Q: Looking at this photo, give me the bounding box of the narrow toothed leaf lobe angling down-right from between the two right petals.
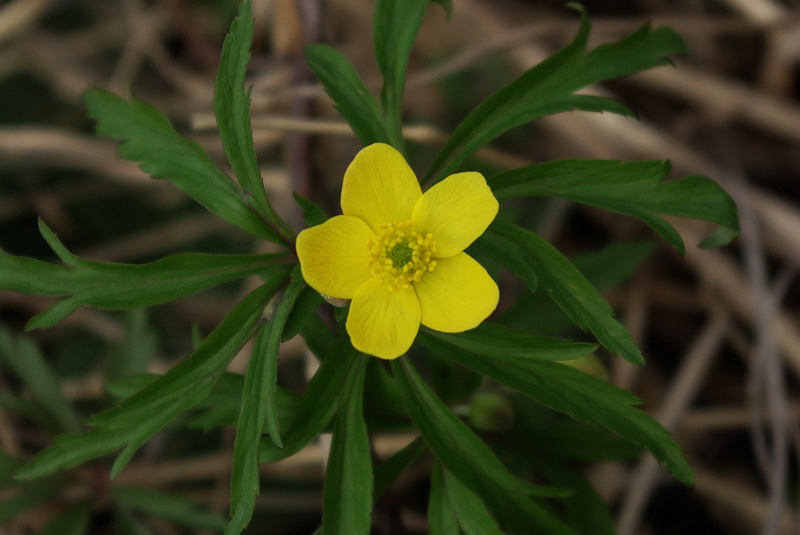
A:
[489,221,644,364]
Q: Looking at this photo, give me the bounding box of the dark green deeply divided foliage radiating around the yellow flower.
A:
[0,0,738,535]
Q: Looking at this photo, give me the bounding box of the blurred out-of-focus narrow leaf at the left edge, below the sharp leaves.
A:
[0,328,80,432]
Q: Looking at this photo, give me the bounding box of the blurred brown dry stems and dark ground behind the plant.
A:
[0,0,800,535]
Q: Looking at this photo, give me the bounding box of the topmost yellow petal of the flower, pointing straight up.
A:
[342,143,422,232]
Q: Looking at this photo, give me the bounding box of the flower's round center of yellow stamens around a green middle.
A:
[367,221,436,292]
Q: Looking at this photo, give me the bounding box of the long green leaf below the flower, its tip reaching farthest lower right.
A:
[443,342,694,486]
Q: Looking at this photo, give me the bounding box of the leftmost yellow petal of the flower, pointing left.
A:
[297,215,376,299]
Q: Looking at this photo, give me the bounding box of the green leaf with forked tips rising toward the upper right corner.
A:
[426,4,686,181]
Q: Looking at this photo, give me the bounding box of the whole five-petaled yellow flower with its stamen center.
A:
[297,143,499,359]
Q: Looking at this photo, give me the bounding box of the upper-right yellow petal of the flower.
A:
[411,172,499,257]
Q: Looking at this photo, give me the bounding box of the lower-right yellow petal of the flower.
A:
[414,253,500,333]
